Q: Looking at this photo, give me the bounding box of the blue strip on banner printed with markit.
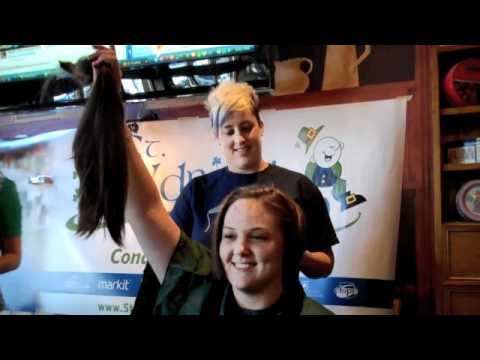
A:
[39,272,143,297]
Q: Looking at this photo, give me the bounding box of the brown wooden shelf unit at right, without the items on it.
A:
[429,45,480,315]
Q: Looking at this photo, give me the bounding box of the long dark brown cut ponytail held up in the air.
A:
[72,64,128,245]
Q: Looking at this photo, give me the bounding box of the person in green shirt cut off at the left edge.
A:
[0,172,22,311]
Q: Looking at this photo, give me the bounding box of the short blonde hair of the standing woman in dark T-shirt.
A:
[205,80,261,134]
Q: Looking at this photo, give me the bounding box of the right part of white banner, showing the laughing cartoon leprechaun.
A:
[263,98,407,314]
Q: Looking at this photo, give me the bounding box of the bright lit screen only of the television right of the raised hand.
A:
[114,45,256,68]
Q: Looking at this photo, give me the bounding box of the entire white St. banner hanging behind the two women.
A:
[0,98,406,314]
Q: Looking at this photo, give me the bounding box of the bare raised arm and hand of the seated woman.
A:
[83,46,180,282]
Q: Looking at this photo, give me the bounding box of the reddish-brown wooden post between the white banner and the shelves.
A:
[404,45,435,314]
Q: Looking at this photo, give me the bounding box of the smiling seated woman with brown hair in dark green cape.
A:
[154,185,333,316]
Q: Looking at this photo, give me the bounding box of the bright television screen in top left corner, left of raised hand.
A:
[0,45,100,83]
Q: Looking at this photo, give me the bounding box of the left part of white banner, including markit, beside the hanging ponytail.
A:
[0,129,146,314]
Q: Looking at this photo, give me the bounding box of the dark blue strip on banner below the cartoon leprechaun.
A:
[300,276,394,309]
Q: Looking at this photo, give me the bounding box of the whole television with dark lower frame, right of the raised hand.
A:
[114,45,271,100]
